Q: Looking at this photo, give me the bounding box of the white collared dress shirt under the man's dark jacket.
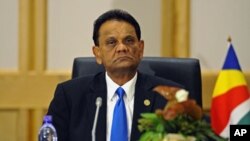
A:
[106,72,137,141]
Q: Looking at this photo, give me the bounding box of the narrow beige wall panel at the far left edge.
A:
[0,0,18,69]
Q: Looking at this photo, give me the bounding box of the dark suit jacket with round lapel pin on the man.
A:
[48,72,183,141]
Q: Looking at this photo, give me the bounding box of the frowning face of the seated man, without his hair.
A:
[93,20,144,73]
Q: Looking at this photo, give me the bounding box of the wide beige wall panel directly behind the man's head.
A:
[48,0,161,70]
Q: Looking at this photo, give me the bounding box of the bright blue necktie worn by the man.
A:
[110,87,128,141]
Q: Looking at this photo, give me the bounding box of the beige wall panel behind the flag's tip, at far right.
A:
[190,0,250,71]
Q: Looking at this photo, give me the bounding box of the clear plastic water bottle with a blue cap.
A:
[38,115,57,141]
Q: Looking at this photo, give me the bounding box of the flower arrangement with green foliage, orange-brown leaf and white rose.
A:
[138,86,226,141]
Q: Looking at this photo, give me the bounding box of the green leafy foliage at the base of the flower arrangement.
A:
[138,113,226,141]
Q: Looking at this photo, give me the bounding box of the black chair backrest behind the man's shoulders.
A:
[72,57,202,106]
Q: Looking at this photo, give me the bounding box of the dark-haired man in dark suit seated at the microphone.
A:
[48,10,180,141]
